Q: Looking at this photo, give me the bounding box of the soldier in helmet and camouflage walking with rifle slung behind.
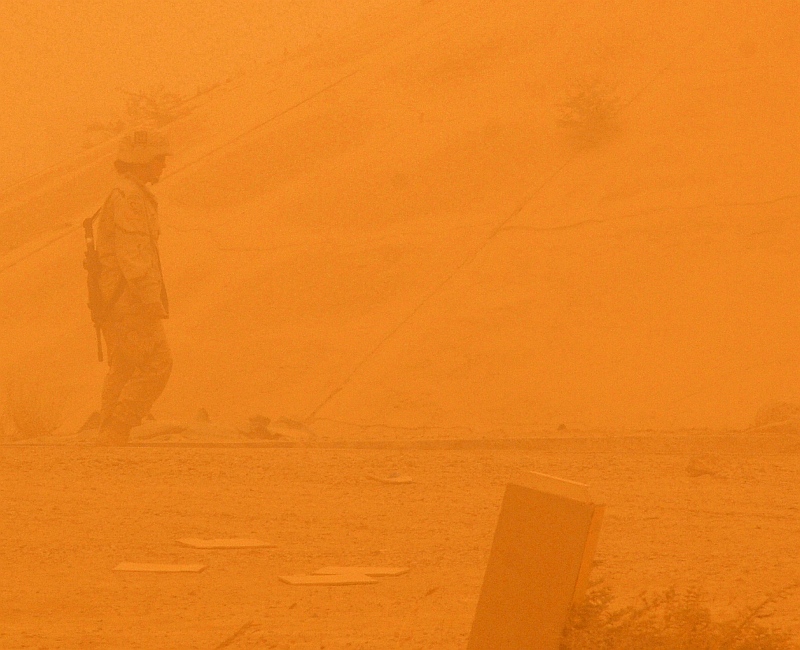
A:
[96,131,172,445]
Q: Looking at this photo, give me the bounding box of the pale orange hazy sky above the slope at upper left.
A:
[0,0,388,187]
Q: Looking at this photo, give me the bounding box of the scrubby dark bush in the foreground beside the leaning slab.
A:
[561,587,797,650]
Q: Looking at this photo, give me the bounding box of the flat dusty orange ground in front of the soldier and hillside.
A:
[0,433,800,650]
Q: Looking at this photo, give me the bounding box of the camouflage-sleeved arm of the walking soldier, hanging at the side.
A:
[113,192,161,305]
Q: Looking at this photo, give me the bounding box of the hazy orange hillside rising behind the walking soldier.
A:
[0,0,800,437]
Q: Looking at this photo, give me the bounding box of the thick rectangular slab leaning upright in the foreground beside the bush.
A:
[468,473,603,650]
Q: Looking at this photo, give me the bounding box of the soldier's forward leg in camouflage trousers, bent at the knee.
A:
[112,318,172,427]
